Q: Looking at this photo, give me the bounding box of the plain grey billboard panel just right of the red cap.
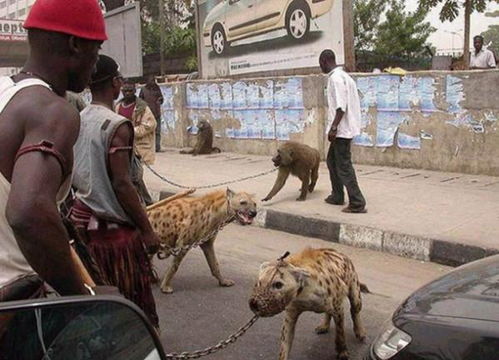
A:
[100,2,142,77]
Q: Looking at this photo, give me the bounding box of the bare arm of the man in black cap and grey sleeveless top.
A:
[109,123,159,252]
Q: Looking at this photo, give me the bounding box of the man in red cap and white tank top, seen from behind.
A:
[0,0,106,301]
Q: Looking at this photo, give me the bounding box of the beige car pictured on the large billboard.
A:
[203,0,333,55]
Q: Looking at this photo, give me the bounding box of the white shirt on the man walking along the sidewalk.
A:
[327,67,361,139]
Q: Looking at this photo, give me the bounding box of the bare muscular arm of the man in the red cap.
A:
[6,99,88,295]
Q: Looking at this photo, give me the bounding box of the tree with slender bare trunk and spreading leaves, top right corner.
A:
[419,0,499,68]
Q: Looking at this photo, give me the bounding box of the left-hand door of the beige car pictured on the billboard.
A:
[226,0,259,39]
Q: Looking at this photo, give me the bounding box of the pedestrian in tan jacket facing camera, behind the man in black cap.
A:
[116,80,157,165]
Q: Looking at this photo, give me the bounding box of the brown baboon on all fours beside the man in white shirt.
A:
[262,141,321,201]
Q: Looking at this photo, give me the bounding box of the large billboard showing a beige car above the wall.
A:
[197,0,344,78]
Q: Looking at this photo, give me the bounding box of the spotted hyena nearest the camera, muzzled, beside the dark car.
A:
[249,248,369,360]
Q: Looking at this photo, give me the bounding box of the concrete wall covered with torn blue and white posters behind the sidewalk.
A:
[162,70,499,176]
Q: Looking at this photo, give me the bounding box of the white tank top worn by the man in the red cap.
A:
[0,77,50,288]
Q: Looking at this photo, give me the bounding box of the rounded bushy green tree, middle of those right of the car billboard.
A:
[374,0,435,58]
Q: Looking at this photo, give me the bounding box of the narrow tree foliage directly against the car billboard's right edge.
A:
[353,0,386,52]
